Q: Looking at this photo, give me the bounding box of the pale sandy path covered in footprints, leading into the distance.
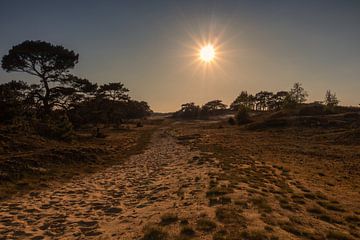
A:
[0,129,215,239]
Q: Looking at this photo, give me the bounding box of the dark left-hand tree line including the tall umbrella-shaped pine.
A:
[0,41,152,138]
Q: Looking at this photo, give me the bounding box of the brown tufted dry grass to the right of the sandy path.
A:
[171,114,360,240]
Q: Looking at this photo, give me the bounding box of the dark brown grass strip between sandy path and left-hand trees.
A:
[0,126,157,200]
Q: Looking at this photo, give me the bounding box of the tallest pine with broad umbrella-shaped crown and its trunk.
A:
[1,41,79,114]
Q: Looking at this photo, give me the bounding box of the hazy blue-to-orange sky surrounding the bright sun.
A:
[0,0,360,111]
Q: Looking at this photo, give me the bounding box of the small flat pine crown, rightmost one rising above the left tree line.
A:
[97,82,130,101]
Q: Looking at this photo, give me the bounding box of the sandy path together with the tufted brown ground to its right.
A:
[0,122,360,240]
